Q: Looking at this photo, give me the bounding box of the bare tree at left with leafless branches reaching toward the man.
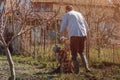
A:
[0,0,61,80]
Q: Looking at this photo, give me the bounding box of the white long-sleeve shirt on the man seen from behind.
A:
[60,10,88,37]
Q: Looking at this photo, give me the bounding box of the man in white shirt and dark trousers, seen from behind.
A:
[60,6,90,74]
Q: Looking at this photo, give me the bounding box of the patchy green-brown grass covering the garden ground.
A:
[0,49,120,80]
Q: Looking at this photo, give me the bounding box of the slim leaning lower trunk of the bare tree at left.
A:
[0,34,16,80]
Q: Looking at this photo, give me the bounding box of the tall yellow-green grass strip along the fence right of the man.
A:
[90,48,120,63]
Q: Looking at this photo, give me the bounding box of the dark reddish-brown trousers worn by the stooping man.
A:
[70,36,88,70]
